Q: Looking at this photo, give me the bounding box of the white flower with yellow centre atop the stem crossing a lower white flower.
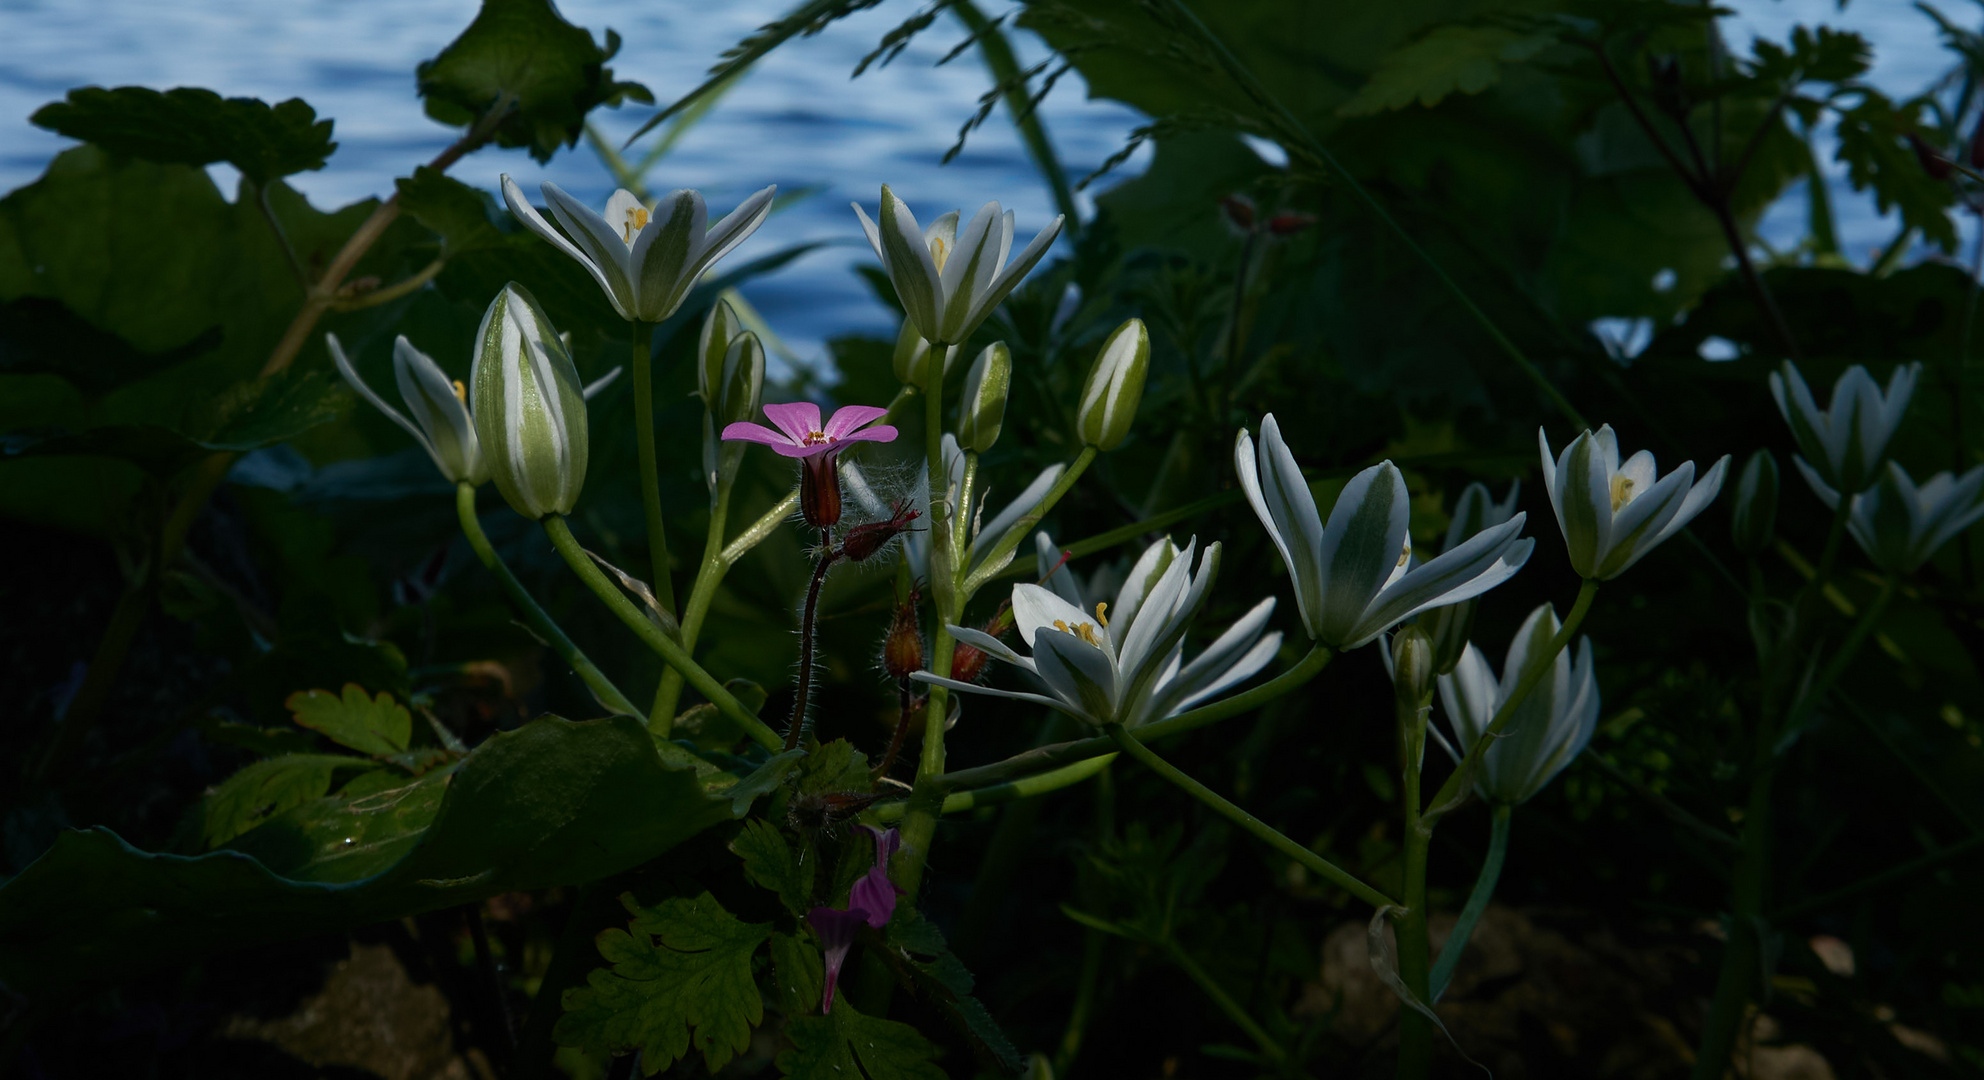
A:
[1536,425,1730,582]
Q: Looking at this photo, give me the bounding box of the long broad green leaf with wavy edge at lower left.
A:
[0,717,732,1001]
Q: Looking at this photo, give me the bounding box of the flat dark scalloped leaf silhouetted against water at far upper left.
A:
[28,85,337,187]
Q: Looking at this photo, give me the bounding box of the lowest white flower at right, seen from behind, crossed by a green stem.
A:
[1434,604,1599,806]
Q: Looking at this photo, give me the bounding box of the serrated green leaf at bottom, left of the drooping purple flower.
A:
[554,893,772,1076]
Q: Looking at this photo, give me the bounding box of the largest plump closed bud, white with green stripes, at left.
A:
[468,282,587,518]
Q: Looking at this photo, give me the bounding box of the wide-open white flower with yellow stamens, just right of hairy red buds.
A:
[913,538,1282,727]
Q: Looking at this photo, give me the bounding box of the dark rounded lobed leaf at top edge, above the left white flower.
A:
[419,0,655,161]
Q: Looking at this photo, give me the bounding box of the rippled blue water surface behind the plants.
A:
[0,0,1976,357]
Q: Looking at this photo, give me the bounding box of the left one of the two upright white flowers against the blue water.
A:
[502,173,778,322]
